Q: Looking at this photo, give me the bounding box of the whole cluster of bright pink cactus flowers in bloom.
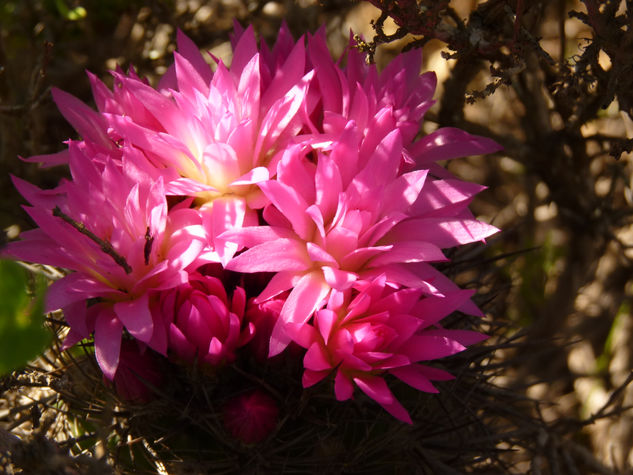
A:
[7,26,499,426]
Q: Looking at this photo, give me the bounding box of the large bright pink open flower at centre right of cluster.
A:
[222,119,497,356]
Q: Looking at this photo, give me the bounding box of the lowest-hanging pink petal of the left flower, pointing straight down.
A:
[95,308,123,381]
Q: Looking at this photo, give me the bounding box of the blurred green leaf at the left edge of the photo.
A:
[0,260,51,374]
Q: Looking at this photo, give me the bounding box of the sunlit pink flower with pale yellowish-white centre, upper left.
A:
[40,28,311,263]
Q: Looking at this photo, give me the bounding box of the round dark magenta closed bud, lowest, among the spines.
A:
[224,389,279,444]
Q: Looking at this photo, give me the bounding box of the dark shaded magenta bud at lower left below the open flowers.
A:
[113,340,163,403]
